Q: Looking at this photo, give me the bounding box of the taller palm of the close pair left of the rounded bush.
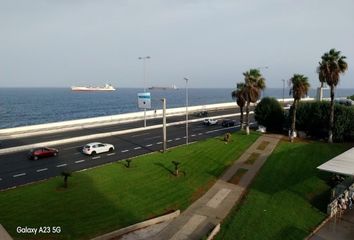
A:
[243,69,265,135]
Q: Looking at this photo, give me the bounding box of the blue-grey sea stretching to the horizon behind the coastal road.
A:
[0,88,354,129]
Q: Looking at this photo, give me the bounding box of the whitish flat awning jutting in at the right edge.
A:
[317,147,354,176]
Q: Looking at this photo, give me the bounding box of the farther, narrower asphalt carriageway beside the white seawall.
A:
[0,107,243,148]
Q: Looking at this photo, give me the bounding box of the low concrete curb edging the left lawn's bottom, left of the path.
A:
[91,210,181,240]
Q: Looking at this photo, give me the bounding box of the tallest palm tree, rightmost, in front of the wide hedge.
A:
[317,48,348,143]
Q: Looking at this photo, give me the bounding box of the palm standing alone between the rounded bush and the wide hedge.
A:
[289,74,310,142]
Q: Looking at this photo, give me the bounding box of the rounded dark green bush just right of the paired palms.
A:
[254,97,284,131]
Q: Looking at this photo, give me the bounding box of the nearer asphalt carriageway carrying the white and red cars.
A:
[0,113,254,190]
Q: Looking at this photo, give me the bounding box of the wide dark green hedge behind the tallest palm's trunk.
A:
[290,102,354,142]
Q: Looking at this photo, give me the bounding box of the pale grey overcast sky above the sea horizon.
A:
[0,0,354,88]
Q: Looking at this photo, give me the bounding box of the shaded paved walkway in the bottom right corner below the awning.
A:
[310,209,354,240]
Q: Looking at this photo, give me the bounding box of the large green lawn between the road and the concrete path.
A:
[0,133,259,240]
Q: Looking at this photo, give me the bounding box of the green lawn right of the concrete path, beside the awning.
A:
[216,141,350,240]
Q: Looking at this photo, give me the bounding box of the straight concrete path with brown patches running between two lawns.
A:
[148,135,281,240]
